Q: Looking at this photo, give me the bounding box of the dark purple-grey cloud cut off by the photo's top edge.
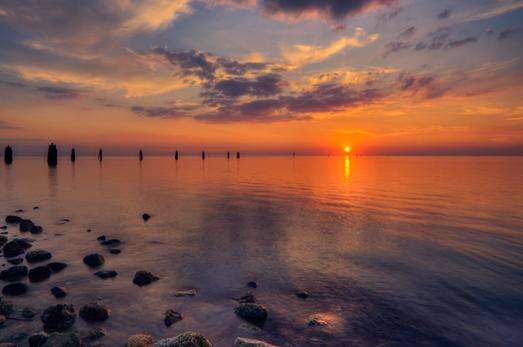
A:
[261,0,395,19]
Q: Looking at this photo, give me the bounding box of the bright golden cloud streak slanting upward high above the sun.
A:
[282,28,379,68]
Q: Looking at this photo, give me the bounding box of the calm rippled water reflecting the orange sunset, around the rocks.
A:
[0,157,523,346]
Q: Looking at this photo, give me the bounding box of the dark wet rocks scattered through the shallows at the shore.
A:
[0,212,308,347]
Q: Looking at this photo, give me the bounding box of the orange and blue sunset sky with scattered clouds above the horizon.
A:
[0,0,523,155]
